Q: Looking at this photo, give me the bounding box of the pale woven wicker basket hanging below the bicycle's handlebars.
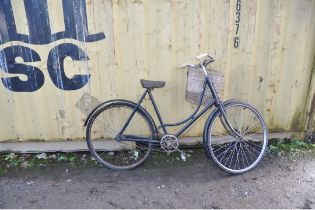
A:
[185,68,224,104]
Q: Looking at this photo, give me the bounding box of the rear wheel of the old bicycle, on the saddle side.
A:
[86,102,154,170]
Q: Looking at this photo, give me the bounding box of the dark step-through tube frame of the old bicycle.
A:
[115,76,223,143]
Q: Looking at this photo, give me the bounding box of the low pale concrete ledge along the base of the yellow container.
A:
[0,132,294,153]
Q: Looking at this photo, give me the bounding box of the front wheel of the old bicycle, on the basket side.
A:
[205,102,268,174]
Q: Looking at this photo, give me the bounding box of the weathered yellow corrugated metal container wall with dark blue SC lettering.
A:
[0,0,315,141]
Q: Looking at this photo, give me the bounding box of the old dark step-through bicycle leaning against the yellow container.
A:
[84,54,268,174]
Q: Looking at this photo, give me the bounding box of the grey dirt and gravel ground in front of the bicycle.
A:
[0,150,315,208]
